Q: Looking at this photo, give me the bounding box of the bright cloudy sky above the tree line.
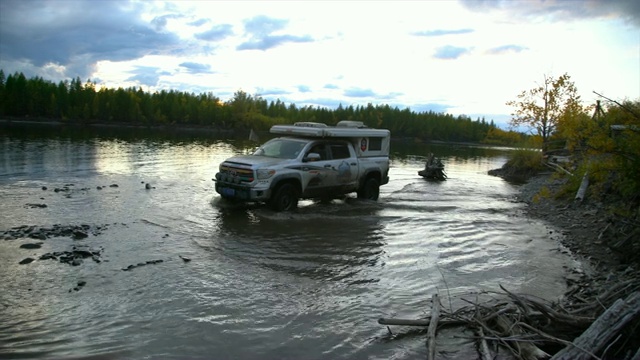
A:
[0,0,640,126]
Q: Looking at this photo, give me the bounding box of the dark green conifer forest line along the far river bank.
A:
[0,70,526,145]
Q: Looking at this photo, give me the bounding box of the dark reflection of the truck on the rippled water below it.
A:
[212,201,384,282]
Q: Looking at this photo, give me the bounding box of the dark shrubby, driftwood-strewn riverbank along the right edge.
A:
[490,169,640,359]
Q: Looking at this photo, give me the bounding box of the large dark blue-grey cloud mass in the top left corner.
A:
[0,0,182,78]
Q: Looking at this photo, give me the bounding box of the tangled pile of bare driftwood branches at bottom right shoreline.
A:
[378,274,640,360]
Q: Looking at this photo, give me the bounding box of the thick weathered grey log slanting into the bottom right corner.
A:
[551,291,640,360]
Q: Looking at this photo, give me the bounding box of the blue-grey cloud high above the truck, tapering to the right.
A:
[236,16,313,51]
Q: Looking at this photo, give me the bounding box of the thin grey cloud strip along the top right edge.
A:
[459,0,640,26]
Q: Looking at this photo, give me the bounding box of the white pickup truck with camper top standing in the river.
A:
[214,120,390,211]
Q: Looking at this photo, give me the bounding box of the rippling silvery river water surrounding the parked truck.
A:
[0,124,571,359]
